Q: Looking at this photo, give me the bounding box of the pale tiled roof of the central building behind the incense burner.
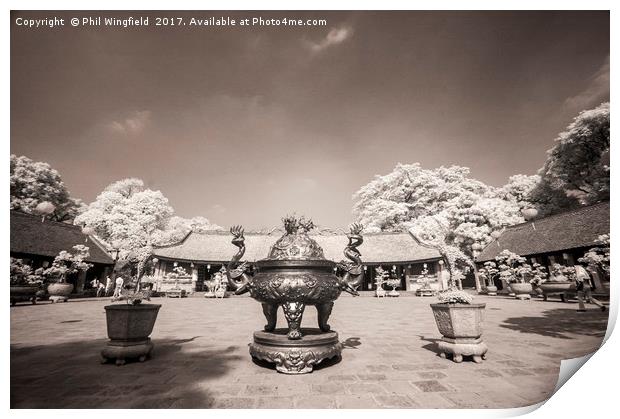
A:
[154,232,440,263]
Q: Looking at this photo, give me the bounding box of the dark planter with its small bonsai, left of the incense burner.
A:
[101,260,161,365]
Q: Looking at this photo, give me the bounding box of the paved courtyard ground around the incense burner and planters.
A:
[11,296,607,408]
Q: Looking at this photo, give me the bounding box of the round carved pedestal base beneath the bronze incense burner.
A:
[250,329,342,374]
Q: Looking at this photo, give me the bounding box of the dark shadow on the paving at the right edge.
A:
[500,308,608,339]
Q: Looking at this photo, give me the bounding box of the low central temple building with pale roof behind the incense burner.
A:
[153,230,442,292]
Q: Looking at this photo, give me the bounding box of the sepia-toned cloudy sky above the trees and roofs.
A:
[10,11,609,228]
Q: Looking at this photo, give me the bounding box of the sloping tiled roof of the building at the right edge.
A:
[476,202,609,262]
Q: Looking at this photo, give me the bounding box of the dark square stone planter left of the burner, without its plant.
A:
[101,304,161,365]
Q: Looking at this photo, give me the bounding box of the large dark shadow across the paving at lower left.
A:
[11,336,241,409]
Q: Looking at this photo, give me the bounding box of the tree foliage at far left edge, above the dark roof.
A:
[10,154,83,221]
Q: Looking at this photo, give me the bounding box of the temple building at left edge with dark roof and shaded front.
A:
[10,211,114,294]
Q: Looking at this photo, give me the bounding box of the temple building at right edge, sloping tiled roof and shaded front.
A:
[476,202,610,291]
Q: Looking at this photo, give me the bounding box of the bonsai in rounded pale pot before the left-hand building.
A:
[36,244,93,303]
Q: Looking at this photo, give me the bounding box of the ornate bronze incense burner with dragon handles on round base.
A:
[227,217,364,374]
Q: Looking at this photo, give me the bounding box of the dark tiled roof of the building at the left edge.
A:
[10,211,114,264]
